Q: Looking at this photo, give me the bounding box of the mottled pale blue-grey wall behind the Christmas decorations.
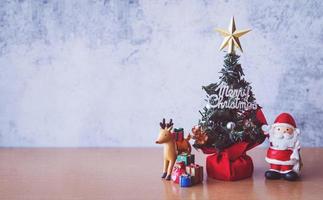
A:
[0,0,323,146]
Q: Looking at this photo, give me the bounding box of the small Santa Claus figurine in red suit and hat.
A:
[263,113,301,181]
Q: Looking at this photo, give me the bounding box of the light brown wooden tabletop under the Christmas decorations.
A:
[0,148,323,200]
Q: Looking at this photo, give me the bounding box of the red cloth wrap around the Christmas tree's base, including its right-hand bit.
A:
[202,109,267,181]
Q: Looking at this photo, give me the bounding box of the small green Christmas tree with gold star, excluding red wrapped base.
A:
[193,18,265,151]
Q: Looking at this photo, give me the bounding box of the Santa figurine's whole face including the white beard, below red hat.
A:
[269,124,297,150]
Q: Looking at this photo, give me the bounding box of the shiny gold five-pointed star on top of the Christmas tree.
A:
[215,17,251,54]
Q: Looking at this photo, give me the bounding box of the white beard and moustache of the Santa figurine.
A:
[269,130,297,150]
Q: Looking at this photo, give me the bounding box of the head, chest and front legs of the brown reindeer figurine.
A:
[156,119,177,181]
